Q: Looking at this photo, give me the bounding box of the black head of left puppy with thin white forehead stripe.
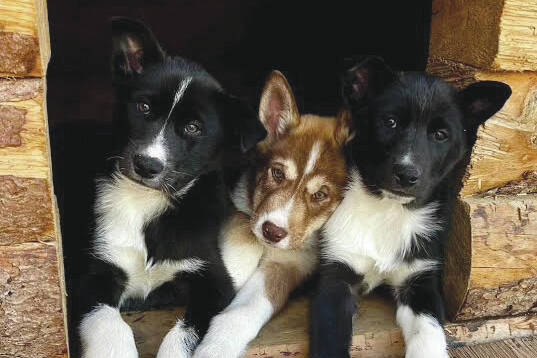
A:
[111,18,265,192]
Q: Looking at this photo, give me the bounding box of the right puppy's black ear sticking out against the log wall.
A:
[458,81,511,128]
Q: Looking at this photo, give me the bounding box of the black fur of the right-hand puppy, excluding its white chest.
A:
[310,57,511,357]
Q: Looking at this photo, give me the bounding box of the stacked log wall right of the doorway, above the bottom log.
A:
[427,0,537,321]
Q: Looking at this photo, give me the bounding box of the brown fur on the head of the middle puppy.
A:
[251,73,350,248]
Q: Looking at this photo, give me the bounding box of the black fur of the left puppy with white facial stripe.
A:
[71,18,265,357]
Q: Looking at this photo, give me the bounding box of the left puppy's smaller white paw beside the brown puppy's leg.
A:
[157,320,198,358]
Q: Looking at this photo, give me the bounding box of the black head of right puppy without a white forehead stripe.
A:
[343,57,511,205]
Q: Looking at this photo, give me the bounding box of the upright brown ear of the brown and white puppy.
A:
[259,71,300,138]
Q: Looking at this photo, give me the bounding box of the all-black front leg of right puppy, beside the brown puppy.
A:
[310,262,363,358]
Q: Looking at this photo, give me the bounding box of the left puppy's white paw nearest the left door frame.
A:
[80,305,138,358]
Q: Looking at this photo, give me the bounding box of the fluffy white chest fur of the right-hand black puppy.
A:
[323,173,440,288]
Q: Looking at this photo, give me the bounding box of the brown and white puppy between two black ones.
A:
[194,71,349,358]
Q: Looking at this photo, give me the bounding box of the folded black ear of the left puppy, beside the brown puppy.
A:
[220,93,267,153]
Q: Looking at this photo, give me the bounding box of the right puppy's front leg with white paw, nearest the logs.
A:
[397,272,448,358]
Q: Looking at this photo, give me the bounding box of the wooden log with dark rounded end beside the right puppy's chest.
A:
[444,172,537,321]
